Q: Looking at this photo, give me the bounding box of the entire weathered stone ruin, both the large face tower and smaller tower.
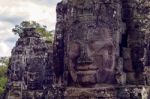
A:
[6,0,150,99]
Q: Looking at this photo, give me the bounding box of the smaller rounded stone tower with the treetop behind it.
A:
[5,28,53,99]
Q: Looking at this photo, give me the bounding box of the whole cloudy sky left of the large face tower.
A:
[0,0,61,57]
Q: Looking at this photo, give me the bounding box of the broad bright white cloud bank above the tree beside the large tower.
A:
[0,0,56,29]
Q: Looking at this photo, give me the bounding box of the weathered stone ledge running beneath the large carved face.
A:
[64,85,150,99]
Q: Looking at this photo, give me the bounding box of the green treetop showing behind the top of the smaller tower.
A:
[12,21,54,43]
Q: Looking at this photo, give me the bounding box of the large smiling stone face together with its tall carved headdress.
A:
[56,0,125,84]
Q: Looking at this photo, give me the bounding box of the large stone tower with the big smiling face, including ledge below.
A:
[54,0,150,99]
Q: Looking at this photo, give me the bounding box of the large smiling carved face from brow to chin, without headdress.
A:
[67,24,115,84]
